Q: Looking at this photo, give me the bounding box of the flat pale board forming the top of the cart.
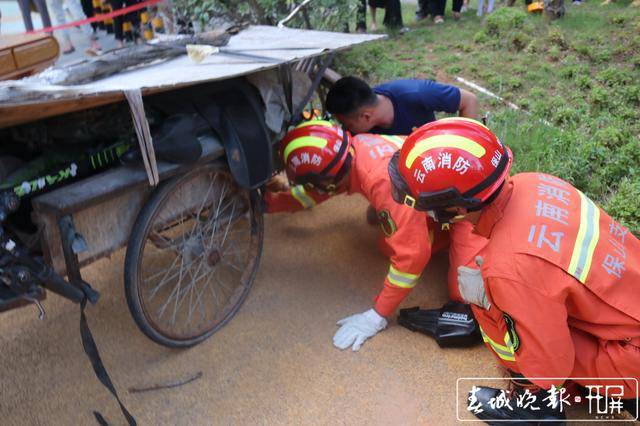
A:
[0,26,385,128]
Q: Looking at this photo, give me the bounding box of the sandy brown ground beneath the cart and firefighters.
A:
[0,196,502,425]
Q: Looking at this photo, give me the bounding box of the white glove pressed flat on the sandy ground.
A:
[333,309,387,352]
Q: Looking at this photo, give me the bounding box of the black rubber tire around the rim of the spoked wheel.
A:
[124,165,264,348]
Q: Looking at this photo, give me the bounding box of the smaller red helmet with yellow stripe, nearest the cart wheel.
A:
[280,120,351,191]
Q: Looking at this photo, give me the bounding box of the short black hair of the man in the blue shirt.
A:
[326,76,378,115]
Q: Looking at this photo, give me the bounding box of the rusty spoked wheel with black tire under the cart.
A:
[124,165,263,347]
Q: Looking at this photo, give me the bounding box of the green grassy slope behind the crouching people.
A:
[335,0,640,235]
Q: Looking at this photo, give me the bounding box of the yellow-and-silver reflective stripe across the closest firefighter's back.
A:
[568,191,600,284]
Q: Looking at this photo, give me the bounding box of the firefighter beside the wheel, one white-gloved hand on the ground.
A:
[264,120,486,351]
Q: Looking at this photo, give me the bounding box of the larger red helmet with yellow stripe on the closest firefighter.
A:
[389,117,512,222]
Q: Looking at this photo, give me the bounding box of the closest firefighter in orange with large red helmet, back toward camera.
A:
[389,120,640,424]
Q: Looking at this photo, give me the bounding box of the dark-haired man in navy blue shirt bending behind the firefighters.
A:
[326,76,478,135]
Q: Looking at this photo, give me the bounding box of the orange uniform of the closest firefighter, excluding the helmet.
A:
[474,173,640,398]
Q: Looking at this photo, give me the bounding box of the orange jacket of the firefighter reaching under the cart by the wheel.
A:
[265,134,446,316]
